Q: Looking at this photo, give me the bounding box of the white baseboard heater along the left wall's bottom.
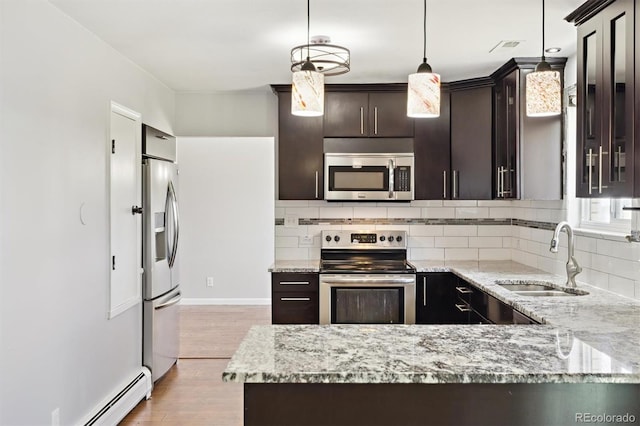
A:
[85,367,153,426]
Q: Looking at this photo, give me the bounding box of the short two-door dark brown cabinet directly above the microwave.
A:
[324,84,413,137]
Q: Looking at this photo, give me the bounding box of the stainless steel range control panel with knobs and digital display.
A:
[322,230,407,249]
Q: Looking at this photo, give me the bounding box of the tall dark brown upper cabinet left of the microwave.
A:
[272,85,324,200]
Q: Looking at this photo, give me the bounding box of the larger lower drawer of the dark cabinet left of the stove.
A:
[271,292,320,324]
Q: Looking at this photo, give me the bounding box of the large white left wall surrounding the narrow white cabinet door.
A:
[0,0,174,425]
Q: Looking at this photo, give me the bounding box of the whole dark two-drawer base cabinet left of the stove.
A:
[271,272,320,324]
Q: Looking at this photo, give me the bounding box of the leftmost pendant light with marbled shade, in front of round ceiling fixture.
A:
[291,0,324,117]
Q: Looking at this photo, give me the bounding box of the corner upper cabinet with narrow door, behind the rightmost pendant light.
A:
[491,58,567,200]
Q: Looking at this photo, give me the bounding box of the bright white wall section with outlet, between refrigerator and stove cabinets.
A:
[178,137,275,304]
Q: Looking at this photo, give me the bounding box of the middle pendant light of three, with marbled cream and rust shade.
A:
[407,0,440,118]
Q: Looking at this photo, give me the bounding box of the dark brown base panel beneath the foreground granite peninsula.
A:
[244,383,640,426]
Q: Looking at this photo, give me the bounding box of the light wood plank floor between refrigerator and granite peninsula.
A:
[120,306,271,426]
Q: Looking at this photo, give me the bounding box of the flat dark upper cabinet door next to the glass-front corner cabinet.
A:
[448,77,493,200]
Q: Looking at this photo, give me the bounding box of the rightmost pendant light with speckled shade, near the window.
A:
[525,0,562,117]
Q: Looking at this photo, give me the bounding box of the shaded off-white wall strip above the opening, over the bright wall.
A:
[175,87,278,136]
